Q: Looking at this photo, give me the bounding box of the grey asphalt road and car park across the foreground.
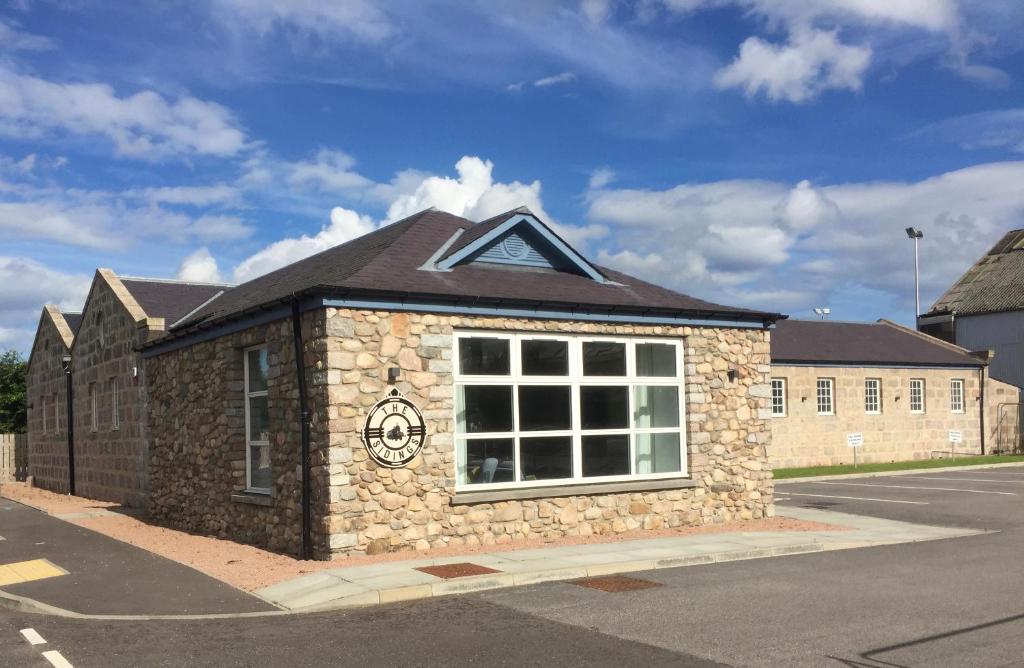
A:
[0,467,1024,667]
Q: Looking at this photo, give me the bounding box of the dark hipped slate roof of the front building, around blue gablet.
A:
[169,210,781,333]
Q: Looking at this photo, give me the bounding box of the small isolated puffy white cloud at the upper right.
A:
[715,30,871,102]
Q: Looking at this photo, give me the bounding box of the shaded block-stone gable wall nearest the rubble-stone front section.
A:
[72,269,151,507]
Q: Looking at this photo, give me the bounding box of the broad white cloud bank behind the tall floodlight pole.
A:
[589,162,1024,315]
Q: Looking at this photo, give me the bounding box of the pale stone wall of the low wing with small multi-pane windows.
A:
[768,365,1017,468]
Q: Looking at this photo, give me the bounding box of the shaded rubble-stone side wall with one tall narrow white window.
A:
[145,310,325,557]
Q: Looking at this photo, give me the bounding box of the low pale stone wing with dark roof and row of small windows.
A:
[768,320,1019,468]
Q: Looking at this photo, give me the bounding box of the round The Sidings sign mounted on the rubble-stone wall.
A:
[362,389,427,468]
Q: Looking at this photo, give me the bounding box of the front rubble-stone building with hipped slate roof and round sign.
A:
[141,209,779,558]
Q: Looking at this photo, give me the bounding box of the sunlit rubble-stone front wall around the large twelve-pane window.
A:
[316,308,774,555]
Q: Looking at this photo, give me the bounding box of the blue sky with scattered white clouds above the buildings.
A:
[0,0,1024,350]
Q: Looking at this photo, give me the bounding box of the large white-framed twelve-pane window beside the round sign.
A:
[455,332,686,489]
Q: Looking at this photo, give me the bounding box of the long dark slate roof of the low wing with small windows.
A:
[771,320,984,367]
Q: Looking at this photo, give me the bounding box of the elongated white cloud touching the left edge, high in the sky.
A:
[0,64,246,161]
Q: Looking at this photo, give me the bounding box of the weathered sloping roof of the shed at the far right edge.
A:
[926,229,1024,316]
